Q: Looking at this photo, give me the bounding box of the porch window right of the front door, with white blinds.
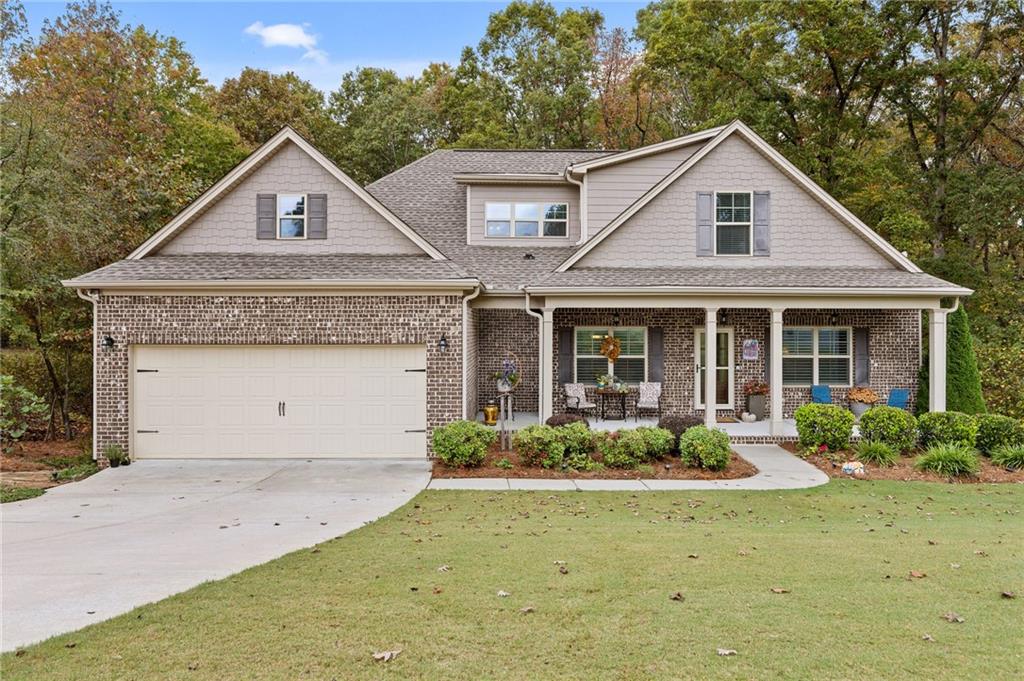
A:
[782,327,853,387]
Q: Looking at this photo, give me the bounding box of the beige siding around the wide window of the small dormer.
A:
[469,184,580,247]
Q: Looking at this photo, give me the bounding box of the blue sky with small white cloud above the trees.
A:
[26,0,646,90]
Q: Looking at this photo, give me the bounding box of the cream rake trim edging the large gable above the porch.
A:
[555,121,922,272]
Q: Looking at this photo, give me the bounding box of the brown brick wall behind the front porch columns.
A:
[554,308,921,418]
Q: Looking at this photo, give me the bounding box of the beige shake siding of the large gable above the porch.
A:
[575,136,894,269]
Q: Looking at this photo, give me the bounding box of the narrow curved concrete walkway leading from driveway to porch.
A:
[428,444,828,492]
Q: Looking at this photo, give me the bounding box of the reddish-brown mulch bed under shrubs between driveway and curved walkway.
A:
[433,445,758,480]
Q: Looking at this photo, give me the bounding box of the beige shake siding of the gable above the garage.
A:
[160,142,422,255]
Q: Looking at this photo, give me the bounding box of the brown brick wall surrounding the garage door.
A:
[94,296,462,454]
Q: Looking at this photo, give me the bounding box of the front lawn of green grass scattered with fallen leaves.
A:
[2,480,1024,681]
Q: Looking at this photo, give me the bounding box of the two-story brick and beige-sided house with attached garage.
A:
[66,122,971,458]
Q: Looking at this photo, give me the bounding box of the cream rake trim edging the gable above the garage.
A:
[127,126,447,260]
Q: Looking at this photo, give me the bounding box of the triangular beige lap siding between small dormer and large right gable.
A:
[587,144,701,237]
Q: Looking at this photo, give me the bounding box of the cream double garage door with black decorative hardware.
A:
[131,345,427,459]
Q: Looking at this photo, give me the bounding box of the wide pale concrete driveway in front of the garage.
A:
[0,460,430,651]
